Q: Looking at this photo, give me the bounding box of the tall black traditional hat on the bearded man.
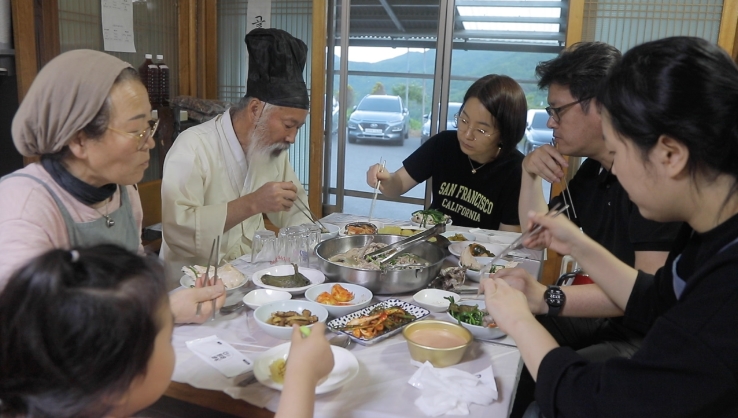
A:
[245,29,310,109]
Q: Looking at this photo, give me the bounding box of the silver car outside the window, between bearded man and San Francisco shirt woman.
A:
[348,94,410,145]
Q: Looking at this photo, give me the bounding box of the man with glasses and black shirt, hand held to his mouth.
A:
[507,42,680,417]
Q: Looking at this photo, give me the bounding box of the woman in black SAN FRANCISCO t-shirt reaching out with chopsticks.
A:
[367,74,527,232]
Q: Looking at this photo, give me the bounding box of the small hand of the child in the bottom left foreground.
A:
[285,322,334,387]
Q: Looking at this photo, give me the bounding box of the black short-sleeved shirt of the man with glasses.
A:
[551,158,682,266]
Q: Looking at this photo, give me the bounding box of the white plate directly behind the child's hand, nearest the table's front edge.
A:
[254,343,359,395]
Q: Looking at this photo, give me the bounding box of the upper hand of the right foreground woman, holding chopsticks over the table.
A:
[523,212,587,255]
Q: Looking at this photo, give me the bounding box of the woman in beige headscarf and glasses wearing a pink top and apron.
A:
[0,50,225,322]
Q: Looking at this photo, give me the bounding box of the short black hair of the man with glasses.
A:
[536,42,621,112]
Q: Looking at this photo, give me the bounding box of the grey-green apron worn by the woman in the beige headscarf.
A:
[0,174,140,253]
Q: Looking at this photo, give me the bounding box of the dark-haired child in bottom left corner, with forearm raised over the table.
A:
[0,244,334,418]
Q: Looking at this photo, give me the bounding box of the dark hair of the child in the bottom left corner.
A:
[0,244,167,418]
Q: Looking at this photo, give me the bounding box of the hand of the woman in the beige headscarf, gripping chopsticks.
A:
[169,274,226,324]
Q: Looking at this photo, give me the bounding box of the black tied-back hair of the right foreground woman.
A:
[597,36,738,198]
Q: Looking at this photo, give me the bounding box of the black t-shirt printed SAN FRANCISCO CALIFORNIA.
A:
[403,131,523,229]
